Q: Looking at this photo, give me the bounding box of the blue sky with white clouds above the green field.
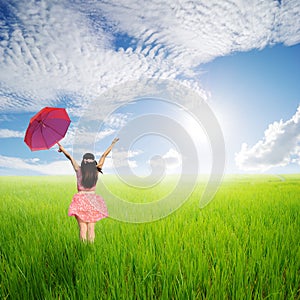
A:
[0,0,300,175]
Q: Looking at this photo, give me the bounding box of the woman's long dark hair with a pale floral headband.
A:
[81,153,98,189]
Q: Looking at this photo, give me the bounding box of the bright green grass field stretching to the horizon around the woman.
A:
[0,175,300,300]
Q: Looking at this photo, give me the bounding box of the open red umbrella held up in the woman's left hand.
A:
[24,107,71,151]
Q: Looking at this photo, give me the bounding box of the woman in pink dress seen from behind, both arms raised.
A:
[58,138,119,242]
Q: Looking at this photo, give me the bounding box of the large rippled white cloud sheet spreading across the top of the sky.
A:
[0,0,300,115]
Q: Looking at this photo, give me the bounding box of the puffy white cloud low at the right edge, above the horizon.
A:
[235,106,300,171]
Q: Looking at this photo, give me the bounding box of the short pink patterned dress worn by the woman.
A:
[68,167,108,223]
